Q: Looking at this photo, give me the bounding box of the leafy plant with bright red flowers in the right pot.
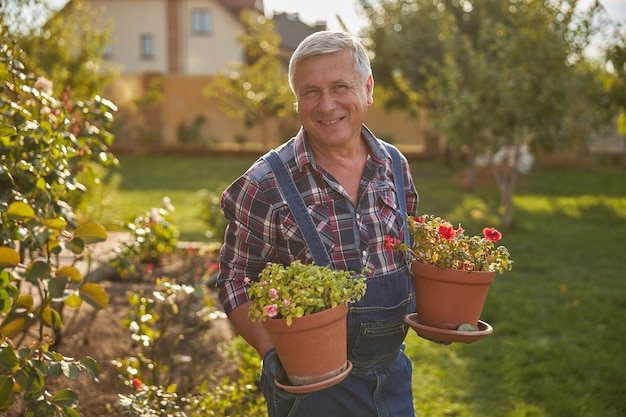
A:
[385,214,513,274]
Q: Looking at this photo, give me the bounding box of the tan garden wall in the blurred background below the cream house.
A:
[107,74,425,153]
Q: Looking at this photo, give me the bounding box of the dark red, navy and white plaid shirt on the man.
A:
[217,126,418,314]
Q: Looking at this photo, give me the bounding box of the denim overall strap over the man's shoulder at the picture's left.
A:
[263,150,330,266]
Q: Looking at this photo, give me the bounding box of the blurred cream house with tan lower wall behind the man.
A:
[84,0,419,153]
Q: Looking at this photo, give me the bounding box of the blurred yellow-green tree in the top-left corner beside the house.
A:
[0,0,120,99]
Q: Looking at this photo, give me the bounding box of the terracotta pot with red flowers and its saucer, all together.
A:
[386,214,513,343]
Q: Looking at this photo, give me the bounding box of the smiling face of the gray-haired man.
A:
[294,50,374,148]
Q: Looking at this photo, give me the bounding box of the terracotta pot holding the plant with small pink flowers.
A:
[263,303,348,385]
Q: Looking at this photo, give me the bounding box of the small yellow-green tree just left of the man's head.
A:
[204,10,294,147]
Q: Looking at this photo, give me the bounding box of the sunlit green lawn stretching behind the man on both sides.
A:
[103,156,626,417]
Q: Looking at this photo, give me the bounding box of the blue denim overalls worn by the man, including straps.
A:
[260,147,415,417]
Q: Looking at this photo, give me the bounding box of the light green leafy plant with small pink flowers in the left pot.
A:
[245,261,367,325]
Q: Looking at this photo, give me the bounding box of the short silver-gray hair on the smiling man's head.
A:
[289,30,372,93]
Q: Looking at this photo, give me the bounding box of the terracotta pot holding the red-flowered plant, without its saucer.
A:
[411,262,495,330]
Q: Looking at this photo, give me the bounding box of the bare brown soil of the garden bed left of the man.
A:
[0,237,236,417]
